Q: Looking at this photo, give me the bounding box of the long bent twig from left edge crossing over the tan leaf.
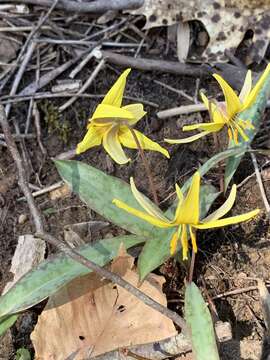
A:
[0,105,187,333]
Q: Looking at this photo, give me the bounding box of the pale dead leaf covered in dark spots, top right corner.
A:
[129,0,270,61]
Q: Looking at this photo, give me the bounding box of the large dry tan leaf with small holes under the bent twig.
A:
[31,246,176,360]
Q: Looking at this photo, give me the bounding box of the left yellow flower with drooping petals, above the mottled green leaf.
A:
[76,69,170,164]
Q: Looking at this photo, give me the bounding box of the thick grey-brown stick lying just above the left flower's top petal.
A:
[101,50,208,77]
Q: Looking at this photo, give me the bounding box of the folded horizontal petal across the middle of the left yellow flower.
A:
[91,104,134,125]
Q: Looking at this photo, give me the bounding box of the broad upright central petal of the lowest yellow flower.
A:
[177,171,200,224]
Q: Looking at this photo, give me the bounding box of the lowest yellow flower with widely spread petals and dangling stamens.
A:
[113,172,260,260]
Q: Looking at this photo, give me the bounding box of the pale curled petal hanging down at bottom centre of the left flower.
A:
[103,126,130,165]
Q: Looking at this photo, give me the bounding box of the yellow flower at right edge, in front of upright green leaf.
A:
[165,64,270,145]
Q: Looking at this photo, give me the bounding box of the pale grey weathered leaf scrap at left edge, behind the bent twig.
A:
[3,234,46,294]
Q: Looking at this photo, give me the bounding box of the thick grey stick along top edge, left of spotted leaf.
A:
[8,0,143,13]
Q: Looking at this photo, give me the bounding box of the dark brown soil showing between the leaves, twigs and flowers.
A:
[0,9,270,360]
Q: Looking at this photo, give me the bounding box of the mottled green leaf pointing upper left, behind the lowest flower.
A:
[55,160,155,237]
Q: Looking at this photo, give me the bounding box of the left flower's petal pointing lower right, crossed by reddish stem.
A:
[119,126,170,158]
